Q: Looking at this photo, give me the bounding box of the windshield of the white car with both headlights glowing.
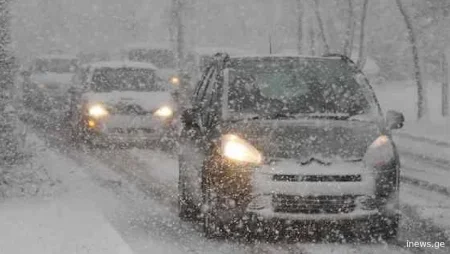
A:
[91,68,165,92]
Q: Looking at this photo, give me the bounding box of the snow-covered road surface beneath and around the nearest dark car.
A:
[8,111,450,253]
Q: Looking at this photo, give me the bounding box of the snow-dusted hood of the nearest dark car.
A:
[225,119,381,163]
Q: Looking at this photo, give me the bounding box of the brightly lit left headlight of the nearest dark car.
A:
[222,134,262,164]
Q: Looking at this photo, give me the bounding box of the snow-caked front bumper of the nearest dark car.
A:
[213,161,399,222]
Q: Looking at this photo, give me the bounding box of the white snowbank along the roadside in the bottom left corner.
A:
[0,134,132,254]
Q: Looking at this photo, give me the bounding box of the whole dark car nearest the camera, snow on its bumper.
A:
[178,54,404,239]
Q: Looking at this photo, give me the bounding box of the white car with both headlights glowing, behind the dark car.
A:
[69,61,176,146]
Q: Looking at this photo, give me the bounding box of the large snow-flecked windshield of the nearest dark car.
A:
[228,58,377,116]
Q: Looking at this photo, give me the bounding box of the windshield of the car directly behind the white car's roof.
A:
[128,49,176,69]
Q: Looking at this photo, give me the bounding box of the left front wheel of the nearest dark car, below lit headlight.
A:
[203,189,224,239]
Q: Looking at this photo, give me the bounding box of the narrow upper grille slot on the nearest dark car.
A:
[272,174,362,182]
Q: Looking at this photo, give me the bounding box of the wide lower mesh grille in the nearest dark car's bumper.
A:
[272,195,356,214]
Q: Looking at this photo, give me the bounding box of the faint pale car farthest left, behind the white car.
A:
[23,54,79,112]
